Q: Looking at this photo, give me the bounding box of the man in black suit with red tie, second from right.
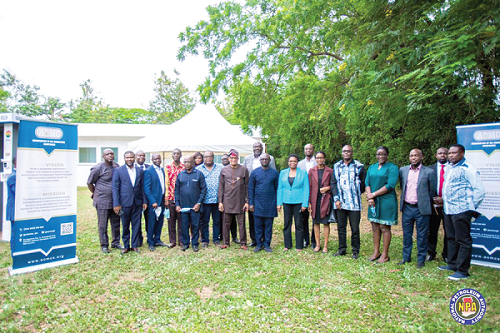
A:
[425,147,449,262]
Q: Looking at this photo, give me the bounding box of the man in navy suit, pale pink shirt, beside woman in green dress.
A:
[398,149,436,268]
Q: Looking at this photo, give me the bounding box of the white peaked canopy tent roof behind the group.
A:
[128,105,255,155]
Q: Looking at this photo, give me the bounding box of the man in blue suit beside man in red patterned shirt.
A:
[144,154,167,251]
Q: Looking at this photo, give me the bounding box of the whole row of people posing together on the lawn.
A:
[87,142,484,280]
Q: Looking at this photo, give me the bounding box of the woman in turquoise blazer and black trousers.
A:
[277,154,309,251]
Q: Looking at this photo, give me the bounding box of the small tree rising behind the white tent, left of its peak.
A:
[149,71,195,124]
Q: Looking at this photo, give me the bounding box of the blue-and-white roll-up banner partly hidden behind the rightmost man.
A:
[457,123,500,268]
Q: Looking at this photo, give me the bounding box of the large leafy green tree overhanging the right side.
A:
[178,0,500,166]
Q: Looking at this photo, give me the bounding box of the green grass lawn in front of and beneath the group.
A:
[0,188,500,332]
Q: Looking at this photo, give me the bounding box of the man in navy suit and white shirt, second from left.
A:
[112,151,147,254]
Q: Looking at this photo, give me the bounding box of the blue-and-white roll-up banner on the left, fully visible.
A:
[9,120,78,275]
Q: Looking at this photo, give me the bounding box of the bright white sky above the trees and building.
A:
[0,0,233,108]
